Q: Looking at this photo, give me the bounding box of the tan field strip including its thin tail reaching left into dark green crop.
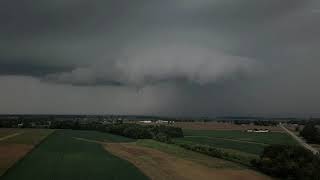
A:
[37,133,268,180]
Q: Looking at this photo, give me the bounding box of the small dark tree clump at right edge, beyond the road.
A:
[300,122,320,144]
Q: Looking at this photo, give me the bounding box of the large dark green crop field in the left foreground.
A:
[1,130,148,180]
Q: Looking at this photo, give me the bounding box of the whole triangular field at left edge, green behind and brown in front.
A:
[0,129,53,176]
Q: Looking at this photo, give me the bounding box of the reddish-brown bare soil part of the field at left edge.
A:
[0,144,33,176]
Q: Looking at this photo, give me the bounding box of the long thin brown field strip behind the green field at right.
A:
[174,122,284,132]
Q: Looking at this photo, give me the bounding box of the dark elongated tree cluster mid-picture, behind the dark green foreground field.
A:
[105,124,183,142]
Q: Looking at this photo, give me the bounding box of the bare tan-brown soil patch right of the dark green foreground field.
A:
[104,143,270,180]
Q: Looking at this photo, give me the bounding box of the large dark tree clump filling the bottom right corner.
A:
[252,145,320,180]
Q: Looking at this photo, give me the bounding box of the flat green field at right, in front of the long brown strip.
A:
[175,130,296,155]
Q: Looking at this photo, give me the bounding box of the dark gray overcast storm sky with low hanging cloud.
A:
[0,0,320,116]
